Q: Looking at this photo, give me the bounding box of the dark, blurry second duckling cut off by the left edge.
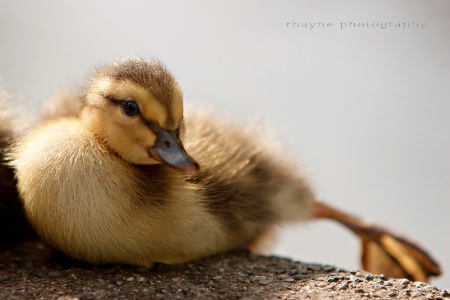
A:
[0,93,36,245]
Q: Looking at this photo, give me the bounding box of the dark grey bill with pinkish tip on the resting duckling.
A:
[149,128,200,174]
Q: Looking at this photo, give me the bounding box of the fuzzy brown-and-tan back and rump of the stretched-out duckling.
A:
[183,112,314,247]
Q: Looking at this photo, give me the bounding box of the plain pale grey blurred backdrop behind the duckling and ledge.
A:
[0,0,450,288]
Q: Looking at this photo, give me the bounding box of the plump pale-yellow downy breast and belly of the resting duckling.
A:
[12,119,235,265]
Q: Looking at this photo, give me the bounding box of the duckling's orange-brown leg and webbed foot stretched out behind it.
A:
[314,202,441,281]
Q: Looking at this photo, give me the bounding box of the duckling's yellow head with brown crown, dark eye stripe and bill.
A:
[80,59,199,174]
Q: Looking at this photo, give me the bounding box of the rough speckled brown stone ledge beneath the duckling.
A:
[0,241,450,299]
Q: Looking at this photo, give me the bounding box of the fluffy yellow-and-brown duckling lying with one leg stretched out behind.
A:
[9,59,440,282]
